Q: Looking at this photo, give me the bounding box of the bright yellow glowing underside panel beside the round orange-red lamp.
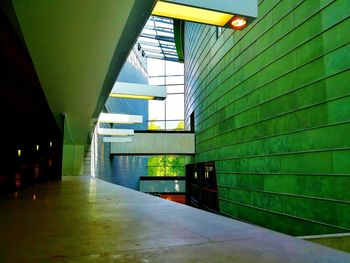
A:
[152,1,233,26]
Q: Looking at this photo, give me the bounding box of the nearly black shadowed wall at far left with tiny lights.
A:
[0,12,62,195]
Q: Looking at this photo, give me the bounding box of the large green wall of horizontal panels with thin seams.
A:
[184,0,350,235]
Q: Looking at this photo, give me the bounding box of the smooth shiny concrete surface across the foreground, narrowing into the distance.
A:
[0,177,350,263]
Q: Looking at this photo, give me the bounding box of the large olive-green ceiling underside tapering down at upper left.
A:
[12,0,155,144]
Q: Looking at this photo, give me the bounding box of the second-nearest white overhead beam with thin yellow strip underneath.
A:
[110,82,167,100]
